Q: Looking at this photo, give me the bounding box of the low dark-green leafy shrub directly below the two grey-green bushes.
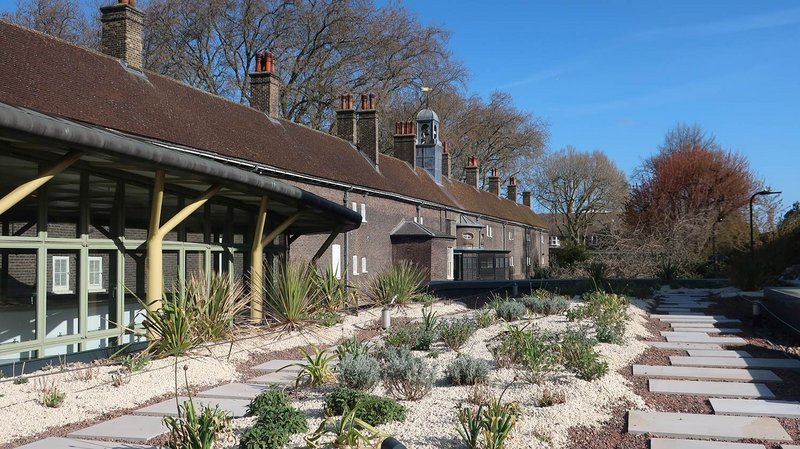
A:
[325,387,406,426]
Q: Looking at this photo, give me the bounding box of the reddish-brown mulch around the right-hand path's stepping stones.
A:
[568,290,800,449]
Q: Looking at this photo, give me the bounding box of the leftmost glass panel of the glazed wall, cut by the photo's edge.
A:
[0,249,37,344]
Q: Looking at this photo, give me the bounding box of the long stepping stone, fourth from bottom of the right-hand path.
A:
[648,379,775,398]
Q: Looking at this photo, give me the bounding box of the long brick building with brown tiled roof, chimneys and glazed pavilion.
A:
[0,2,548,364]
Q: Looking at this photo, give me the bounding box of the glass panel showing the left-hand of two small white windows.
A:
[45,249,81,338]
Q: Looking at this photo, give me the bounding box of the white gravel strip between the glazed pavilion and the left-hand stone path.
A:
[0,303,466,443]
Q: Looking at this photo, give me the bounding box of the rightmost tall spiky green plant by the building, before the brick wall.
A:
[367,261,425,306]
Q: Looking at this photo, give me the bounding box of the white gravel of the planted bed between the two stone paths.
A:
[224,300,650,449]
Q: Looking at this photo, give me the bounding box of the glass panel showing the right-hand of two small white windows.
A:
[86,251,118,331]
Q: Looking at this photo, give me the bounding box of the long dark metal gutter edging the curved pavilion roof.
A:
[0,102,361,230]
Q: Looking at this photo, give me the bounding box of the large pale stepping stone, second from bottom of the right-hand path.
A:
[628,410,792,441]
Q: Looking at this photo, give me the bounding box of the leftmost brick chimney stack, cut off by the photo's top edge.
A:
[100,0,144,71]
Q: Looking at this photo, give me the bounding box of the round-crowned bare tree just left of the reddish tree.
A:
[531,146,628,244]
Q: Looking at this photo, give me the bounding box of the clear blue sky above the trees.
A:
[404,0,800,208]
